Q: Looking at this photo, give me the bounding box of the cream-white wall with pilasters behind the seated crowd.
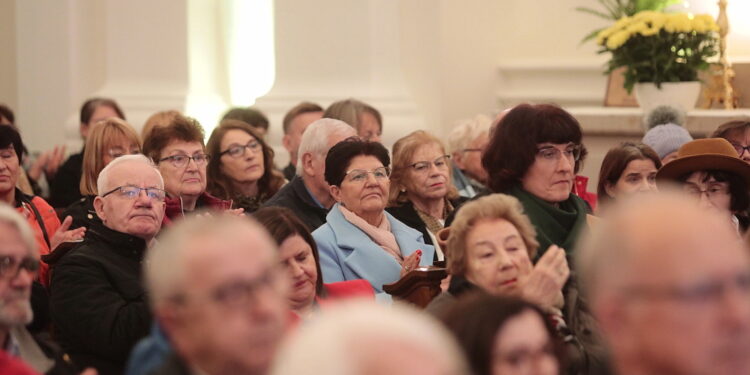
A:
[5,0,750,164]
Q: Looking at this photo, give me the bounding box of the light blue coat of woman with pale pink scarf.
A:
[313,204,435,300]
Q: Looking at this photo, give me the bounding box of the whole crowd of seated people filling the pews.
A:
[0,98,750,375]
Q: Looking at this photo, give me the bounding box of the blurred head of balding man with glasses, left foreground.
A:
[145,215,289,375]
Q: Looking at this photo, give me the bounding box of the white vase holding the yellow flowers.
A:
[635,81,701,113]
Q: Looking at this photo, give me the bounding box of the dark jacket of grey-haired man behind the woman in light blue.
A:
[263,176,328,232]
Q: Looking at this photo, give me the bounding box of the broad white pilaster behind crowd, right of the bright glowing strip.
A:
[256,0,423,165]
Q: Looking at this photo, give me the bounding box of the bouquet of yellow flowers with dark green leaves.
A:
[596,11,719,93]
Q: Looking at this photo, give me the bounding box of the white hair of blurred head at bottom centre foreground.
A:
[271,300,468,375]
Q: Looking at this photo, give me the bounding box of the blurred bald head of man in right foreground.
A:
[577,192,750,375]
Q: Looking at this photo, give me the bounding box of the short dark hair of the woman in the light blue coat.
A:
[325,138,391,186]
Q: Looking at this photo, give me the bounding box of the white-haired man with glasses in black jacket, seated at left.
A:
[50,155,166,375]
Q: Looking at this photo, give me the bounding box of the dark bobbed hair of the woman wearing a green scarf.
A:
[482,104,588,193]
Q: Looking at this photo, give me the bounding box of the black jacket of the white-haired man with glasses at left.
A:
[50,224,151,375]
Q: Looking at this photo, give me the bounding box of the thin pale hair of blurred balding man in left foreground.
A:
[143,214,274,308]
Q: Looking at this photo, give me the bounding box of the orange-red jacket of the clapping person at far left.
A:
[16,192,60,287]
